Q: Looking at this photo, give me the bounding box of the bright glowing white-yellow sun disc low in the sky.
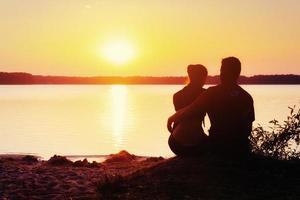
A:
[101,39,136,66]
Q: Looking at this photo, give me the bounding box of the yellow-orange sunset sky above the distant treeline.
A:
[0,0,300,76]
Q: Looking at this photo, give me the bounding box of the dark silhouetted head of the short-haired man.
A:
[220,57,241,84]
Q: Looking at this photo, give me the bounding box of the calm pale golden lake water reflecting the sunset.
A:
[0,85,300,158]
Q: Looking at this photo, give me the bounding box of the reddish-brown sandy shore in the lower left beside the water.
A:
[0,151,164,200]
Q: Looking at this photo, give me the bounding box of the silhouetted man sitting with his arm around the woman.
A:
[168,57,254,154]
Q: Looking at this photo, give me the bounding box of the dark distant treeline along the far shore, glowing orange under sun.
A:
[0,72,300,84]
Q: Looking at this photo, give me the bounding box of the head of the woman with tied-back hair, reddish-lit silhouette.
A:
[187,64,207,86]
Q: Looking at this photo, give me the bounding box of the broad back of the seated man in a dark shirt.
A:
[206,84,254,152]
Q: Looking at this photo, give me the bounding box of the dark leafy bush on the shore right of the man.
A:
[250,106,300,160]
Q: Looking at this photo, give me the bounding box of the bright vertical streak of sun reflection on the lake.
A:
[110,85,127,151]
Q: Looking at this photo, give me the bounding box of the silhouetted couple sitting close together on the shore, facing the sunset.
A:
[167,57,254,156]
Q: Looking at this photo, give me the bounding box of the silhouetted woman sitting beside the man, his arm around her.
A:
[168,64,207,155]
